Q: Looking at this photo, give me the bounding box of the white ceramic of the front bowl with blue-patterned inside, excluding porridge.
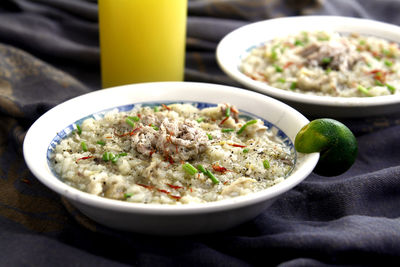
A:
[23,82,319,235]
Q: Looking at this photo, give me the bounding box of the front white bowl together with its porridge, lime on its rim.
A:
[23,82,319,235]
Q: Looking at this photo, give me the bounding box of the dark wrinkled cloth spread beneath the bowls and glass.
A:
[0,0,400,266]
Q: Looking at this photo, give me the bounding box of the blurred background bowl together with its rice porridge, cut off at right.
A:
[217,16,400,118]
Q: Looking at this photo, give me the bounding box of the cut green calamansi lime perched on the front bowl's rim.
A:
[294,118,358,176]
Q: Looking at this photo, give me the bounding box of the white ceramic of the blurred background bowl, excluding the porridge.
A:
[216,16,400,118]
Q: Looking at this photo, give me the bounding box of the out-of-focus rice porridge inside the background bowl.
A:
[240,31,400,97]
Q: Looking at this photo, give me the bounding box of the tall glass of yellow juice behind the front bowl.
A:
[98,0,187,88]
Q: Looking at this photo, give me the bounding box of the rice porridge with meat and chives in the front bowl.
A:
[50,103,295,204]
